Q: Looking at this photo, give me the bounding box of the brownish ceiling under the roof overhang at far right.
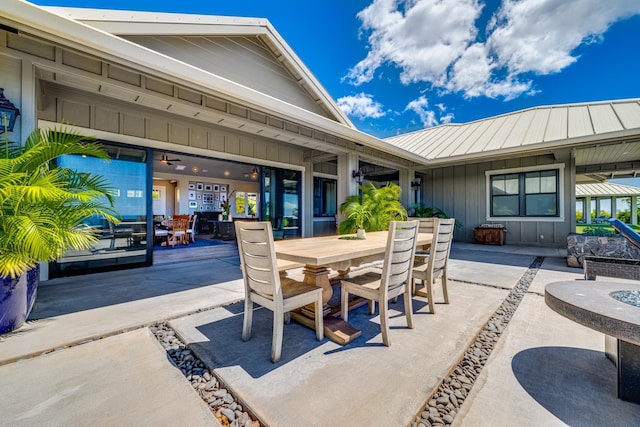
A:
[574,141,640,184]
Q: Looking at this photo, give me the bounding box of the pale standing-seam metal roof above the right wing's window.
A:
[385,98,640,164]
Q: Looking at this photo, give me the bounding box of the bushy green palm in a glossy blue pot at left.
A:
[0,127,119,334]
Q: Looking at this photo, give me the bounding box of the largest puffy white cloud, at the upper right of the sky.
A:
[344,0,640,99]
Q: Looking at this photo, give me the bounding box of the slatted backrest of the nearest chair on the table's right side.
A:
[380,221,420,292]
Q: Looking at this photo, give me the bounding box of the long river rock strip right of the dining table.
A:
[411,257,544,427]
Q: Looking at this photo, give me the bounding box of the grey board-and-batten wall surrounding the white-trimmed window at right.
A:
[423,155,575,247]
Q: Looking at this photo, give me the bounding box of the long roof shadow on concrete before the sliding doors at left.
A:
[29,255,242,320]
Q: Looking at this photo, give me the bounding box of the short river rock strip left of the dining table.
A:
[149,323,263,427]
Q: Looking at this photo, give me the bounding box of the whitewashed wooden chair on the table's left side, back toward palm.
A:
[235,221,324,363]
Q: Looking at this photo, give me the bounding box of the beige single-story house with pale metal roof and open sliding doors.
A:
[0,0,640,277]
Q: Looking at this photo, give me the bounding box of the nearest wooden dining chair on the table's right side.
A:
[341,221,419,347]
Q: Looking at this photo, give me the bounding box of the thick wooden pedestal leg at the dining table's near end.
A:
[291,265,362,345]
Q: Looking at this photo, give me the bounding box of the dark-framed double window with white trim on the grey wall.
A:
[489,169,560,217]
